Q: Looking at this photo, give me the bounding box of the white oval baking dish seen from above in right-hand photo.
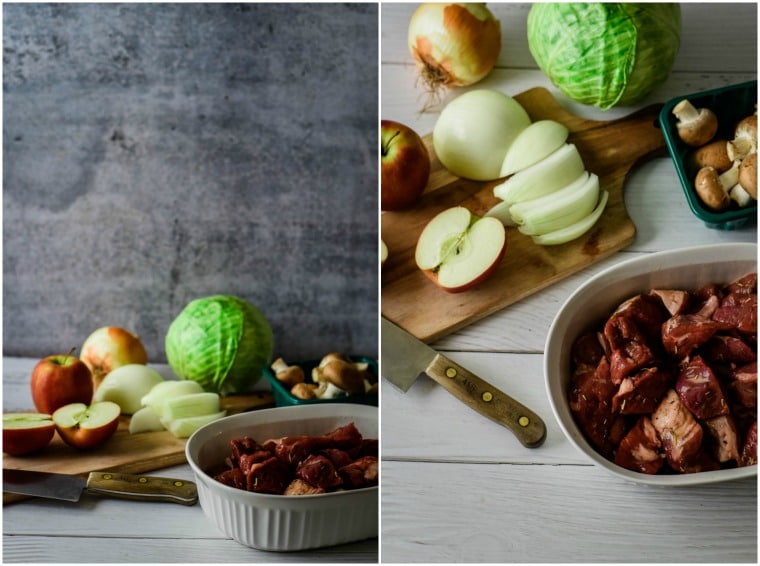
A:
[544,244,757,486]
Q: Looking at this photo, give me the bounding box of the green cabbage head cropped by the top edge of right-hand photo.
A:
[528,3,681,110]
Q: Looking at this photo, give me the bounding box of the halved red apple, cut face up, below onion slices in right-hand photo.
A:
[415,206,507,293]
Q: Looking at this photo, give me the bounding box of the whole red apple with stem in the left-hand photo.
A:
[31,354,93,414]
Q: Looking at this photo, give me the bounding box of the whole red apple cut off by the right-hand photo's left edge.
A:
[380,120,430,210]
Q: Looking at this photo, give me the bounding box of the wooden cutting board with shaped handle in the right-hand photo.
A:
[381,88,667,342]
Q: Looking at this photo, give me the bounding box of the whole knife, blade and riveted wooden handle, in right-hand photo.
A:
[380,317,546,448]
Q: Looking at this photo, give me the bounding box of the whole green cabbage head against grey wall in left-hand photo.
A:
[165,295,274,395]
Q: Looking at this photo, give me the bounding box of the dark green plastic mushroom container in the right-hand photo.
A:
[660,80,757,230]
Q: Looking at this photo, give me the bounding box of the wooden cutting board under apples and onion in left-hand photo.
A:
[3,391,274,504]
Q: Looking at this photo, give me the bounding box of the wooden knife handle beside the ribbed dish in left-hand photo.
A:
[87,472,198,505]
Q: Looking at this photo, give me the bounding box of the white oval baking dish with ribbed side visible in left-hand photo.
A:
[185,403,379,552]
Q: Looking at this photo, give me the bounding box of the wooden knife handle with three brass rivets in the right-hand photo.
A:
[425,354,546,448]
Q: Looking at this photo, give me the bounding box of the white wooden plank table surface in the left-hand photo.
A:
[3,358,378,564]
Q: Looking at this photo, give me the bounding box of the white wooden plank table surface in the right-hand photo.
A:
[380,4,757,563]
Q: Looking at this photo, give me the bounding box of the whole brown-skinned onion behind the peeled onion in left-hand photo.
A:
[80,326,148,390]
